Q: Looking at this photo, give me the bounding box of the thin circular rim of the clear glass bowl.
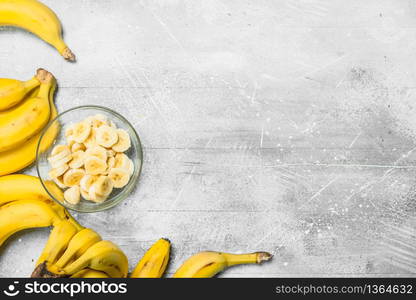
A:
[36,105,143,213]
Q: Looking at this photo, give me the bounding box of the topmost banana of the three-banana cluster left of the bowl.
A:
[0,69,42,111]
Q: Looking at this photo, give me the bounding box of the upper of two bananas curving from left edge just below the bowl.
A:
[0,174,83,230]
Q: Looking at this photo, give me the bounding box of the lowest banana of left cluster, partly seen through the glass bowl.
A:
[0,73,59,176]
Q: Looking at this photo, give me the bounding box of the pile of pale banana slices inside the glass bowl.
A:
[48,114,134,205]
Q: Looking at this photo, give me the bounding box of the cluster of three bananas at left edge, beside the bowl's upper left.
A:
[0,69,59,176]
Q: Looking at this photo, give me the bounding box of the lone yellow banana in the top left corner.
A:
[0,0,75,61]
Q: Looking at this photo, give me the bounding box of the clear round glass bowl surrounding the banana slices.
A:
[36,105,143,212]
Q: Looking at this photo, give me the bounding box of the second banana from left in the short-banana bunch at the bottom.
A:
[55,228,101,269]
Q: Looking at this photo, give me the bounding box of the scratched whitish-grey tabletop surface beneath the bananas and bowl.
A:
[0,0,416,277]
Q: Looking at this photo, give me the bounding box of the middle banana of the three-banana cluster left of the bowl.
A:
[0,70,54,152]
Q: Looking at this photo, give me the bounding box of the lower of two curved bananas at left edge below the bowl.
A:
[0,200,60,246]
